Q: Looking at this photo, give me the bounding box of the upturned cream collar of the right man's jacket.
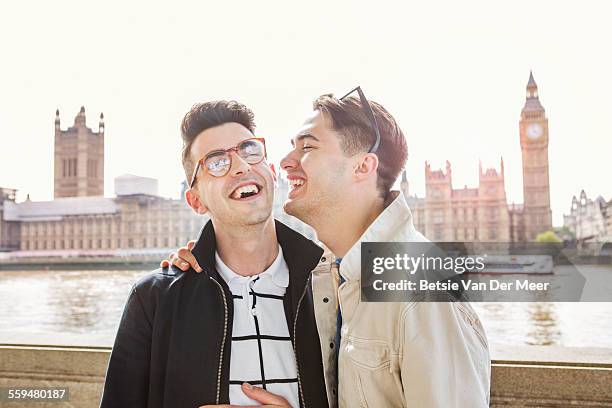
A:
[340,191,424,281]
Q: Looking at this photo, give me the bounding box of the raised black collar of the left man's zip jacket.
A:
[192,220,323,306]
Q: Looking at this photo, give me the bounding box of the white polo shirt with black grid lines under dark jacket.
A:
[215,245,300,407]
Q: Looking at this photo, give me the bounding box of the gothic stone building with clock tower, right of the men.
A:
[401,73,552,242]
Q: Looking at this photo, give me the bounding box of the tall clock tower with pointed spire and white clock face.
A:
[519,72,552,241]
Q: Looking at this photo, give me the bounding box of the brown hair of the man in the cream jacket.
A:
[313,94,408,198]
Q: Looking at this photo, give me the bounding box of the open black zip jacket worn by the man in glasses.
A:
[100,221,328,408]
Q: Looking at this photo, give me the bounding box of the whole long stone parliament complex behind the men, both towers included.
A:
[0,74,552,254]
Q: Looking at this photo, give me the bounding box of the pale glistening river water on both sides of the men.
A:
[0,267,612,348]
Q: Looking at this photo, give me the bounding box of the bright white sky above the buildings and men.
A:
[0,0,612,225]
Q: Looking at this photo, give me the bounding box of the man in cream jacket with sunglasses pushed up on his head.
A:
[171,87,490,408]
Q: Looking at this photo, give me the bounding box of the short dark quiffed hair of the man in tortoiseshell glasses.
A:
[181,101,255,180]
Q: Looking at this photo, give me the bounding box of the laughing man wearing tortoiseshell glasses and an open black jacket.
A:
[101,101,329,408]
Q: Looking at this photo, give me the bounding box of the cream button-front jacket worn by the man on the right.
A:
[312,192,491,408]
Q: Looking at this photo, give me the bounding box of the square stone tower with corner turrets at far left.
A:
[53,106,104,198]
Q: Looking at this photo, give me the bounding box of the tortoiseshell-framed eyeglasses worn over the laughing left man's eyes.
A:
[189,137,266,188]
